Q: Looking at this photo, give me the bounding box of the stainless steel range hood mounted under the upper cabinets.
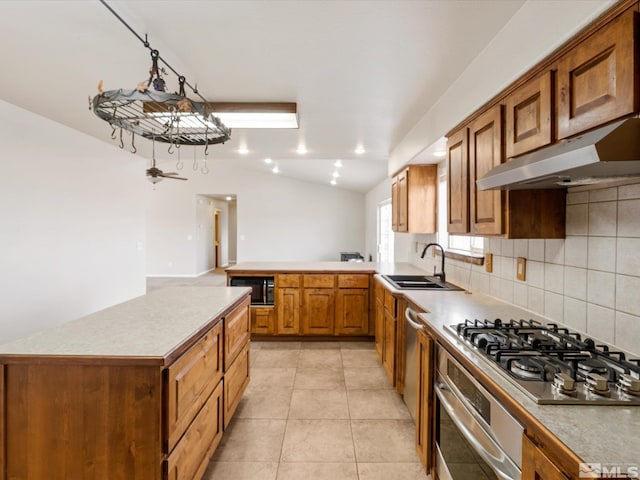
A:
[476,118,640,190]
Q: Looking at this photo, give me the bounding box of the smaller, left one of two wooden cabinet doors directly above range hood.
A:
[505,71,554,158]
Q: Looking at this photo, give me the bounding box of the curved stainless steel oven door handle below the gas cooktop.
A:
[435,382,521,480]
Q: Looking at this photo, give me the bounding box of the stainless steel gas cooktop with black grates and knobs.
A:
[448,319,640,405]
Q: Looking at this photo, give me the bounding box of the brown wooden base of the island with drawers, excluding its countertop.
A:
[0,294,249,480]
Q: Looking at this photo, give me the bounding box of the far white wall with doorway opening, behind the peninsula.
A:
[147,161,365,275]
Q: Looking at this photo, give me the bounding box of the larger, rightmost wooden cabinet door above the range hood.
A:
[557,10,638,138]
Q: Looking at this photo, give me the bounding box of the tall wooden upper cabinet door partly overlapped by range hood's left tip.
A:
[469,105,504,235]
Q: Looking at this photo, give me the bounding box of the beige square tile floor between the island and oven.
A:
[204,341,429,480]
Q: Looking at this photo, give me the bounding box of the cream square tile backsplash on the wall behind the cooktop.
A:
[409,184,640,355]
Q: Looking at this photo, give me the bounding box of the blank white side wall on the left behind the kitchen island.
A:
[0,100,148,342]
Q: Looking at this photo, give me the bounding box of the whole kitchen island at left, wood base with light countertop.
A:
[0,287,250,480]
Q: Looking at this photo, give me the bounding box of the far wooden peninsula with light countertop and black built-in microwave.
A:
[226,262,425,338]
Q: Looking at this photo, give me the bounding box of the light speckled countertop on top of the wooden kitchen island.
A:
[0,287,251,358]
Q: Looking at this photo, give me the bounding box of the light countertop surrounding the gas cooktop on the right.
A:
[386,283,640,474]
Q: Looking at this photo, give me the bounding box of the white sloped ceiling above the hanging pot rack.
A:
[0,0,524,192]
